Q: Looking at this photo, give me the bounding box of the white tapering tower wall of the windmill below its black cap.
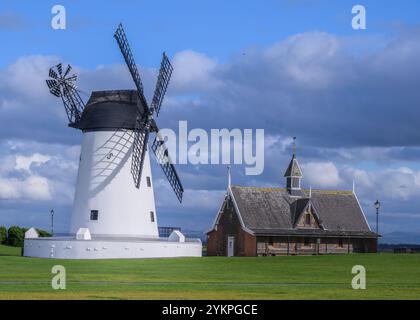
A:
[70,130,158,237]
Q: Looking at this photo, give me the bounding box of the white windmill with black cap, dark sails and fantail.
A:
[25,24,201,258]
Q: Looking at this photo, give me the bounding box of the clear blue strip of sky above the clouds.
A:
[0,0,420,67]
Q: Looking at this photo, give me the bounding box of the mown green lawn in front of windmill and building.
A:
[0,246,420,299]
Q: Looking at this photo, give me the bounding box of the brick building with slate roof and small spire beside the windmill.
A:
[207,154,377,256]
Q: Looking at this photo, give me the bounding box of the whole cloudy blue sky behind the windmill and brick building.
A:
[0,0,420,240]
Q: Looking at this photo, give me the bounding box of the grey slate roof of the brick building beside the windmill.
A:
[231,186,376,236]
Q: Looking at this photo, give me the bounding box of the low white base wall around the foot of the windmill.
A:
[24,237,202,259]
